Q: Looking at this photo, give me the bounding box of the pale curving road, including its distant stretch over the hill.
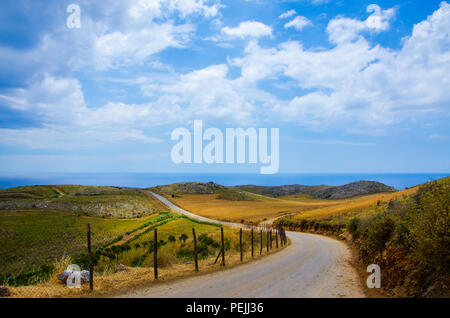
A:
[122,193,365,298]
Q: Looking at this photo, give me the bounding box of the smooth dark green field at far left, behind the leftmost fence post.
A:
[0,210,159,284]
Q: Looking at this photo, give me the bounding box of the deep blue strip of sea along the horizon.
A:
[0,173,444,190]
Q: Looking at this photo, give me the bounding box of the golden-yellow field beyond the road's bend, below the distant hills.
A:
[167,188,417,222]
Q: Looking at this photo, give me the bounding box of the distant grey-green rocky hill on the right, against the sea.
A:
[235,181,396,200]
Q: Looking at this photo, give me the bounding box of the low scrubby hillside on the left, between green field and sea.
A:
[0,185,165,218]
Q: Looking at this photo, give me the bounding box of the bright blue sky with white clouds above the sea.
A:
[0,0,450,174]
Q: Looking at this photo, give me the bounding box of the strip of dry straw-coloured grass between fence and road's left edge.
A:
[7,231,284,298]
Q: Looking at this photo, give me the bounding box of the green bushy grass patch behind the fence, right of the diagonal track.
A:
[96,216,255,271]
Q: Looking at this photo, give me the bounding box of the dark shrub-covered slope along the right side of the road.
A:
[276,178,450,297]
